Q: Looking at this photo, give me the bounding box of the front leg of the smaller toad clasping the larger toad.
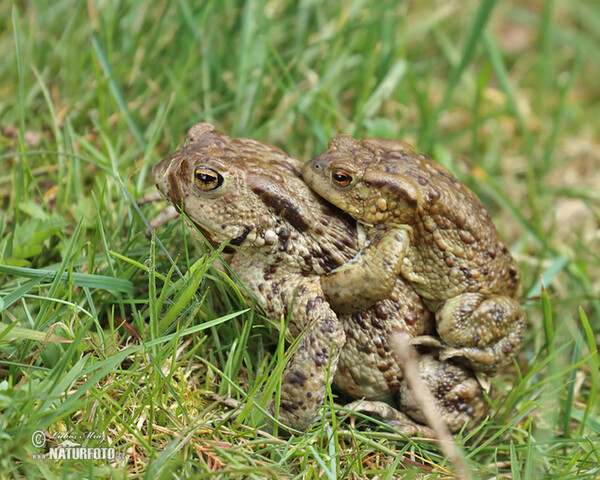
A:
[321,229,408,313]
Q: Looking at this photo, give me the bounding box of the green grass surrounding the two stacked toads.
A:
[0,0,600,479]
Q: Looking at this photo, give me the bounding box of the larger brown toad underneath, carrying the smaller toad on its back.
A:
[154,123,487,433]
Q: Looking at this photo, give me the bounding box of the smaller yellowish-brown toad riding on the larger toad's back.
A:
[303,135,525,373]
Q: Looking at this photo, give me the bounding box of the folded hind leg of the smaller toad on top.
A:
[436,293,526,374]
